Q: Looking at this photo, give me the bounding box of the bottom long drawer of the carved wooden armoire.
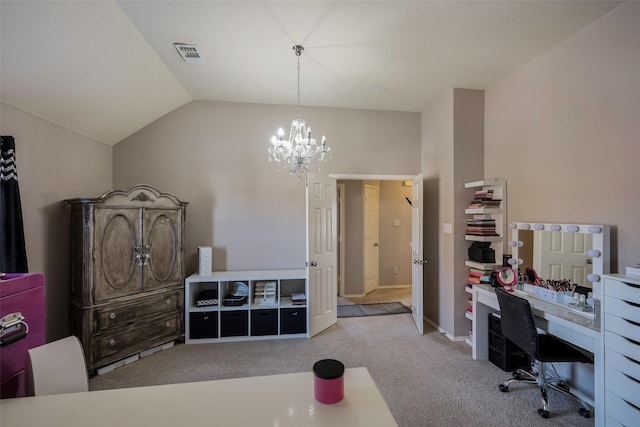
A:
[94,312,182,359]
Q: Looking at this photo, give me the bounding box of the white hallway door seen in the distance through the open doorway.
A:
[364,184,380,294]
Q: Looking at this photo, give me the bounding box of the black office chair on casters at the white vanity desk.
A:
[496,288,593,418]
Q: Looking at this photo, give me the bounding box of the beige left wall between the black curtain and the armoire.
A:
[0,103,112,341]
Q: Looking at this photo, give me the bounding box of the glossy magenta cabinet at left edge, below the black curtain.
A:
[0,273,45,399]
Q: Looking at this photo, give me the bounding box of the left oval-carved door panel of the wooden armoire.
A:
[94,208,142,302]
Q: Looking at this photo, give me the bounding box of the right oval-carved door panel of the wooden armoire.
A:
[143,209,182,290]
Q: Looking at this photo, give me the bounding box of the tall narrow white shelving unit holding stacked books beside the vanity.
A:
[464,179,507,346]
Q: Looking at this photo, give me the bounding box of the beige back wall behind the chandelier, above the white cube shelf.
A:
[113,102,420,273]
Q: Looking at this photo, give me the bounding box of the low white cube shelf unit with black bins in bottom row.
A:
[184,269,309,344]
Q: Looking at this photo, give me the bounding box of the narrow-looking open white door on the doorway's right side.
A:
[411,174,424,334]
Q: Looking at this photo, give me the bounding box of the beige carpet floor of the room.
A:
[90,314,594,427]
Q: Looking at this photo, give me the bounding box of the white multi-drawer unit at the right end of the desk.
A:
[602,275,640,426]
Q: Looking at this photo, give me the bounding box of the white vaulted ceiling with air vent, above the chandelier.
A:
[0,0,621,144]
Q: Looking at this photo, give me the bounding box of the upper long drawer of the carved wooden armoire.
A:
[94,290,182,333]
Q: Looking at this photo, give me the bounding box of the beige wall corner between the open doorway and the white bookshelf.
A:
[422,89,484,337]
